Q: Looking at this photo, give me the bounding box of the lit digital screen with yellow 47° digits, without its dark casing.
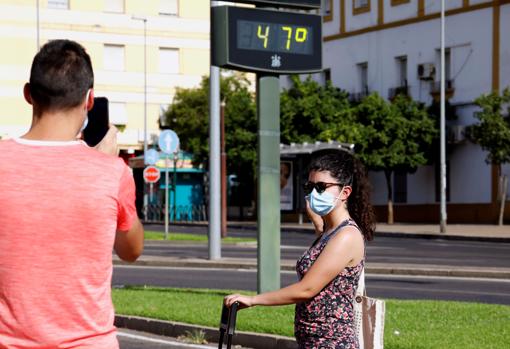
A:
[237,20,313,55]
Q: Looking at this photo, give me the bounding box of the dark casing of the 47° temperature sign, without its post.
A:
[212,6,322,74]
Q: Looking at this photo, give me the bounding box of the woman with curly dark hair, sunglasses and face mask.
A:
[225,150,375,349]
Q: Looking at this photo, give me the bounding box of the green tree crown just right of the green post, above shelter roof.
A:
[280,75,352,144]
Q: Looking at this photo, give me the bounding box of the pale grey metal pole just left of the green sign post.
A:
[208,1,221,260]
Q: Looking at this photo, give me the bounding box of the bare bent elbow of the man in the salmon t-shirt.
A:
[113,217,143,262]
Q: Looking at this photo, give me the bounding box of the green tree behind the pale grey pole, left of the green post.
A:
[164,73,257,204]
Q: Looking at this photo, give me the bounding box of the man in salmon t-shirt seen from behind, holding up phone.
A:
[0,40,143,349]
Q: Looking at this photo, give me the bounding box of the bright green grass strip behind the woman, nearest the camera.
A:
[113,287,510,349]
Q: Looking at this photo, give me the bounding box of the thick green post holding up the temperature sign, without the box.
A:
[257,75,280,293]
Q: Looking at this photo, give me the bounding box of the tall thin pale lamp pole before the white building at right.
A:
[440,0,446,233]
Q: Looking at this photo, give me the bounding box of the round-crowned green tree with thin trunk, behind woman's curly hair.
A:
[354,93,437,224]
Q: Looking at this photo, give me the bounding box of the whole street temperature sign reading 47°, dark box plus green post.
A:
[211,0,322,293]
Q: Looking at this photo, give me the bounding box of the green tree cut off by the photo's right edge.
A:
[468,88,510,225]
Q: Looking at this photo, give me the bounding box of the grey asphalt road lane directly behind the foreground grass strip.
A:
[112,266,510,305]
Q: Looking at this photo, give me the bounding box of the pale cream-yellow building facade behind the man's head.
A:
[0,0,210,154]
